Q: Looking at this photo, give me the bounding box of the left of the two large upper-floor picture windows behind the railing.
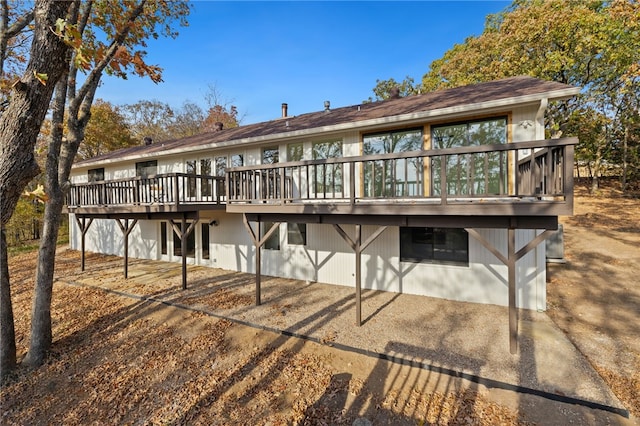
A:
[363,129,423,197]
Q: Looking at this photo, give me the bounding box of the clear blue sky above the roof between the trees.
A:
[97,1,510,124]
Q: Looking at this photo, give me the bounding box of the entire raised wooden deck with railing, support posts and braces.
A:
[67,138,578,353]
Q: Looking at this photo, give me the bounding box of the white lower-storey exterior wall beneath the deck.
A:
[70,216,546,310]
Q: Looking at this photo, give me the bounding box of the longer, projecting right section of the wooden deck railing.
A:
[227,138,577,204]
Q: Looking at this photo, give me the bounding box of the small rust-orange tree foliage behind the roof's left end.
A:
[78,99,137,159]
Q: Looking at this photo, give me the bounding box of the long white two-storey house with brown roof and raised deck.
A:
[68,77,579,352]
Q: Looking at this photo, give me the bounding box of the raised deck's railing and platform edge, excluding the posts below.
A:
[68,138,577,217]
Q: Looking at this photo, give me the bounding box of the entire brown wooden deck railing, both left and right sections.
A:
[67,138,578,210]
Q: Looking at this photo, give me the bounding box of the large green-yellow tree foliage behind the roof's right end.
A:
[422,0,640,189]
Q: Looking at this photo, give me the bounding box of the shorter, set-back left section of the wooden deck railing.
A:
[67,173,226,207]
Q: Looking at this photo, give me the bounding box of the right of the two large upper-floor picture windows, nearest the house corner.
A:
[431,117,507,195]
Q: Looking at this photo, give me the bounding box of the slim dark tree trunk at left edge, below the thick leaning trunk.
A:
[0,225,16,382]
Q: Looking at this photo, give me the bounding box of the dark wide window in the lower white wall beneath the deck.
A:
[400,227,469,265]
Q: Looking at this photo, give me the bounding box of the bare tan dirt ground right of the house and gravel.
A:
[547,180,640,418]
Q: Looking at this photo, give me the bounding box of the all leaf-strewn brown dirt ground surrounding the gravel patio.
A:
[0,181,640,425]
